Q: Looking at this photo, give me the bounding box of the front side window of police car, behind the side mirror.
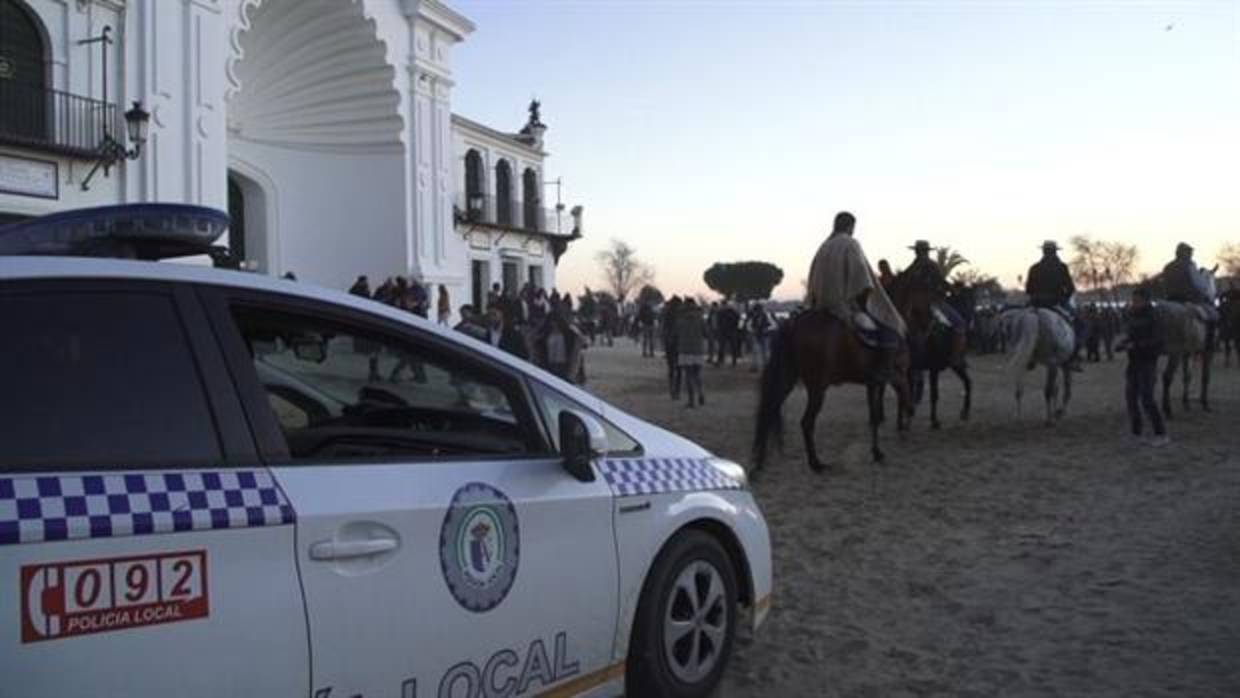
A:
[233,305,541,462]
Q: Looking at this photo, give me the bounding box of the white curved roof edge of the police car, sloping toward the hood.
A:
[0,255,706,455]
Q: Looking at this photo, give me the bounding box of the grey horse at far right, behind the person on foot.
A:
[1154,269,1218,419]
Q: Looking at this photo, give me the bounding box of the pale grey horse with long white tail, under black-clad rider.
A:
[999,307,1076,425]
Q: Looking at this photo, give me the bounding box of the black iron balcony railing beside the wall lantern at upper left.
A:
[0,79,125,157]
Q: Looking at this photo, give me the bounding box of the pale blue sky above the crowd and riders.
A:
[450,0,1240,299]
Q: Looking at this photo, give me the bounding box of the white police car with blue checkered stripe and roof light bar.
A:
[0,206,771,698]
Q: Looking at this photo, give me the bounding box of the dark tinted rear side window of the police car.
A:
[0,290,223,470]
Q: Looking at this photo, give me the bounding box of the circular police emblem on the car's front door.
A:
[439,482,521,612]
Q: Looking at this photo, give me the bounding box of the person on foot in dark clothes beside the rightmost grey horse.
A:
[1117,286,1171,448]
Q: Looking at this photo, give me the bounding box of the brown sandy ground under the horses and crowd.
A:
[588,341,1240,698]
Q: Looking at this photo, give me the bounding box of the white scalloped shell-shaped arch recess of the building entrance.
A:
[226,0,410,288]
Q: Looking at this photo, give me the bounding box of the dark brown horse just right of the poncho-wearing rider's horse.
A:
[890,272,973,430]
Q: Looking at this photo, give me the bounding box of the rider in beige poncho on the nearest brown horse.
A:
[806,211,905,383]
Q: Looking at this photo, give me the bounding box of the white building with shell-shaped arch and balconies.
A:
[0,0,580,305]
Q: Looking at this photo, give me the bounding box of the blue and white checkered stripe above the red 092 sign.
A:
[0,470,296,546]
